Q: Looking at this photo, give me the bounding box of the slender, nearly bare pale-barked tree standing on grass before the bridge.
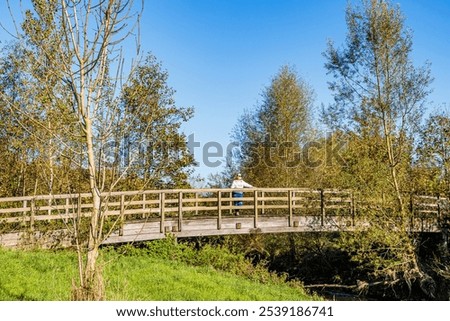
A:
[24,0,142,300]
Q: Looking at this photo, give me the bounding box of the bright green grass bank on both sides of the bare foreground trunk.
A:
[0,245,317,301]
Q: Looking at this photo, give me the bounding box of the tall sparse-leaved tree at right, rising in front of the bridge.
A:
[324,0,433,294]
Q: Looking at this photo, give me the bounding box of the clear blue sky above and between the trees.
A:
[0,0,450,177]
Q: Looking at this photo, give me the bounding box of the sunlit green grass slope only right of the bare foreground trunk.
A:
[105,258,310,301]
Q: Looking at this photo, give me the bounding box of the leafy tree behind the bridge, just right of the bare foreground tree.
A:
[118,55,194,188]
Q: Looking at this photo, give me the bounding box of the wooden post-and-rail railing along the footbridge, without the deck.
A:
[0,188,448,233]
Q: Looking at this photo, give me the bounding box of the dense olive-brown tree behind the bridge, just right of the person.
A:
[233,66,313,187]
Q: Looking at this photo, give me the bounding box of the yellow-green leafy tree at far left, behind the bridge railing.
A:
[0,1,86,196]
